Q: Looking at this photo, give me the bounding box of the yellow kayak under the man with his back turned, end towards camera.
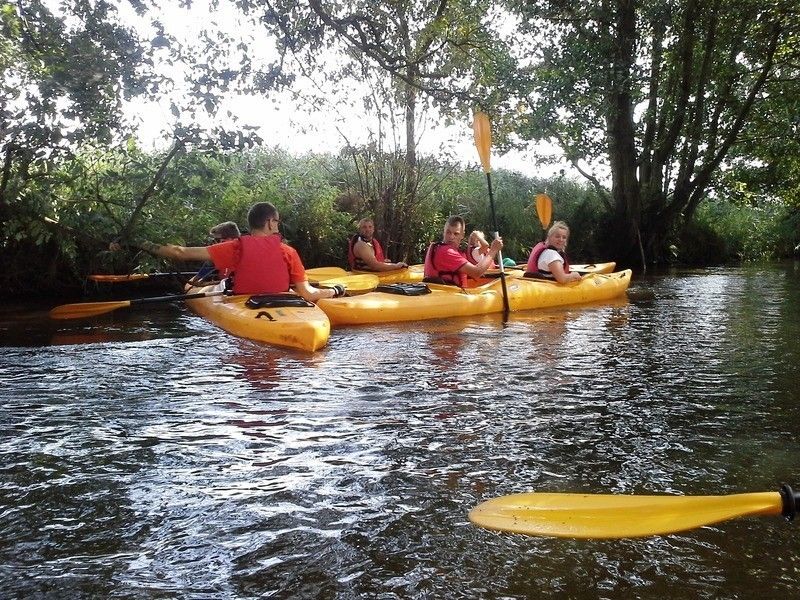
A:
[186,286,331,352]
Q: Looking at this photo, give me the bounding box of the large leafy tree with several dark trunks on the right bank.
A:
[502,0,800,260]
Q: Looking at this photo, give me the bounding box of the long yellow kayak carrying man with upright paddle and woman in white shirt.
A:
[319,270,631,327]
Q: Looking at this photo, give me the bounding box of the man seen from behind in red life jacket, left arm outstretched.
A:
[126,202,344,302]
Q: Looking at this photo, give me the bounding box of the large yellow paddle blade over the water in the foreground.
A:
[469,492,783,539]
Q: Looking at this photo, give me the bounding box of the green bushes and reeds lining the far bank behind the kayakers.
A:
[0,144,800,294]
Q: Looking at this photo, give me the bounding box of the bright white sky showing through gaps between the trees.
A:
[51,0,570,177]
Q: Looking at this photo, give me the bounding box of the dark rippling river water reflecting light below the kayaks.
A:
[0,263,800,599]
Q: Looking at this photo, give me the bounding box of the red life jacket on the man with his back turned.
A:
[233,234,290,294]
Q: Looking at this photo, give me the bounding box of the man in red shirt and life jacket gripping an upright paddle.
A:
[423,215,503,287]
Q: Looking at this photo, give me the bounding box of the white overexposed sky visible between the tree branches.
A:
[120,0,568,177]
